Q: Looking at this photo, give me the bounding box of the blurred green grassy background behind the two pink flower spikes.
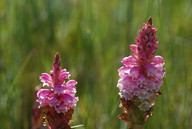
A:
[0,0,192,129]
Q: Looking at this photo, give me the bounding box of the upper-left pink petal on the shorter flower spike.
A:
[40,73,53,87]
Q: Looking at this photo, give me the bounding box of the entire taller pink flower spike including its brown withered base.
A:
[117,18,165,129]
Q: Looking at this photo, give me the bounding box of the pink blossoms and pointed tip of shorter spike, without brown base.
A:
[37,53,78,114]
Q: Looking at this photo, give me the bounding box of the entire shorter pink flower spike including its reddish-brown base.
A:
[37,52,78,129]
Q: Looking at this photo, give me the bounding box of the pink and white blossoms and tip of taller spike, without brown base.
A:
[117,18,165,111]
